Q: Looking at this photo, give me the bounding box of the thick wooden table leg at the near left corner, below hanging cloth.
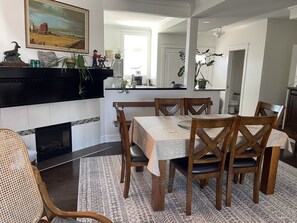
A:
[151,160,166,211]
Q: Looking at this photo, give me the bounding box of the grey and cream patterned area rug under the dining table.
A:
[78,155,297,223]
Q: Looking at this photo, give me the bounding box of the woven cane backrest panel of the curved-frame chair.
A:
[0,129,43,222]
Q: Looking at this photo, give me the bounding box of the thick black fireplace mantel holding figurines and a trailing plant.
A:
[0,66,113,108]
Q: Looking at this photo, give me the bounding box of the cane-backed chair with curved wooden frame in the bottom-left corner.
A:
[0,128,111,223]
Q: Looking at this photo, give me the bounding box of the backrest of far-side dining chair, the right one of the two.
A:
[184,98,212,115]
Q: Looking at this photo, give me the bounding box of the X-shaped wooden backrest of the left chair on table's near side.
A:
[188,117,235,173]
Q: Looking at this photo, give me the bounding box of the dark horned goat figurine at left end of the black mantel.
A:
[0,41,29,67]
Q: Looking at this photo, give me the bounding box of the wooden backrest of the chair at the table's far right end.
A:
[255,101,285,128]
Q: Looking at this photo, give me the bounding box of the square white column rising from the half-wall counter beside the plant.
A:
[184,18,198,93]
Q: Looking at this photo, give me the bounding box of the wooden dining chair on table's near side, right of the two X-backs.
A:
[225,116,276,207]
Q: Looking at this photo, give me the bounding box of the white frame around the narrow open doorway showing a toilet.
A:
[224,43,249,114]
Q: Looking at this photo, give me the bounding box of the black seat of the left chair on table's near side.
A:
[172,157,219,174]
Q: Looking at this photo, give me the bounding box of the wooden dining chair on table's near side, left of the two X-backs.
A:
[168,117,235,215]
